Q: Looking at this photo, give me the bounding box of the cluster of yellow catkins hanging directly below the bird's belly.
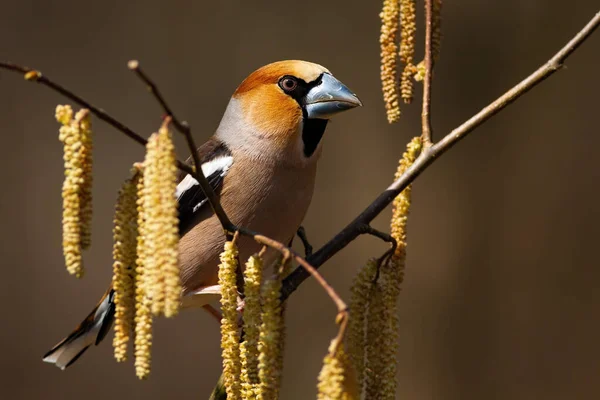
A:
[219,244,284,400]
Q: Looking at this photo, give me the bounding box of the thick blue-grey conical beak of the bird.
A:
[305,74,362,119]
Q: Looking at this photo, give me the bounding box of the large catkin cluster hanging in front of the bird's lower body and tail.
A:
[108,125,181,379]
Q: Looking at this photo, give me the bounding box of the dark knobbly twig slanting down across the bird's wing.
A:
[127,60,235,234]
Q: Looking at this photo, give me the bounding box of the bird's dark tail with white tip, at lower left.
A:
[43,288,115,370]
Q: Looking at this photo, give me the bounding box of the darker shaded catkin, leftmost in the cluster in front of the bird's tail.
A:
[113,174,139,362]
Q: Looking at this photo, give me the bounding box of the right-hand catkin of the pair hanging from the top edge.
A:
[400,0,417,104]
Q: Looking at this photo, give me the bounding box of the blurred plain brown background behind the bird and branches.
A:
[0,0,600,400]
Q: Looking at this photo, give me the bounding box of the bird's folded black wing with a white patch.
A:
[175,138,233,233]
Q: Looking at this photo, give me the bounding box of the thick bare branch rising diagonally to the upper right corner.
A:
[282,12,600,299]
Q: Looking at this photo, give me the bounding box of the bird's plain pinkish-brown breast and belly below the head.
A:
[180,161,316,293]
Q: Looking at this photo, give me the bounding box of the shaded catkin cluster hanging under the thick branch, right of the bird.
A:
[347,137,422,400]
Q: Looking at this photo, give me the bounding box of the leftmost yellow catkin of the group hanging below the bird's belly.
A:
[219,242,242,400]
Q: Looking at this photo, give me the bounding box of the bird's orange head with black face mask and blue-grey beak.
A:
[217,60,362,164]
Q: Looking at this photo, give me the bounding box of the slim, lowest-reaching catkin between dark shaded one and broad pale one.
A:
[135,170,152,379]
